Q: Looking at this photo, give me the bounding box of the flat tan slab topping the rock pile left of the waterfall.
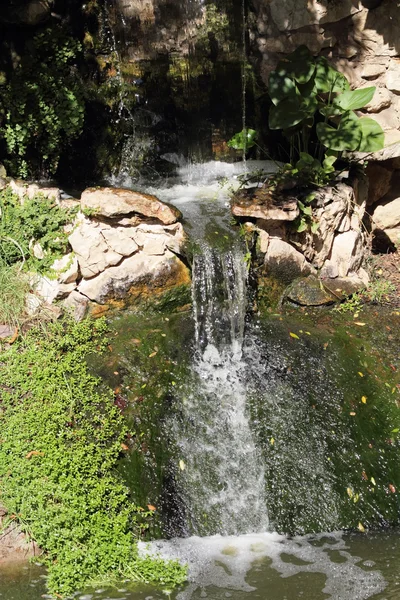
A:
[81,187,181,225]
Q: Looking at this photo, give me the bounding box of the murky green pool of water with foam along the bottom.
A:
[0,530,400,600]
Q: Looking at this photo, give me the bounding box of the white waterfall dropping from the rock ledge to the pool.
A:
[174,239,268,535]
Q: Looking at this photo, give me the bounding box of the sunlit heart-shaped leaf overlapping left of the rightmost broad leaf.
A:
[317,112,362,151]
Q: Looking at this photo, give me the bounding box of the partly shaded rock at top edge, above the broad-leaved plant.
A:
[270,0,360,31]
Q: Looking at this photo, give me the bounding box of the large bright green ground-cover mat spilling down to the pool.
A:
[0,320,185,595]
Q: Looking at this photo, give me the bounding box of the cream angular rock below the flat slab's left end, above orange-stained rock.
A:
[68,220,125,278]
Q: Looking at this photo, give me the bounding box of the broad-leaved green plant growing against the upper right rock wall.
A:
[269,46,384,172]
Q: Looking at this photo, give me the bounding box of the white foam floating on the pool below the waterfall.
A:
[140,533,386,600]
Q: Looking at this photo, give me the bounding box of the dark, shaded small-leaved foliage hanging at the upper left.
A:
[0,28,84,177]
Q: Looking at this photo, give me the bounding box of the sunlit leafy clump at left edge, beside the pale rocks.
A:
[0,188,74,273]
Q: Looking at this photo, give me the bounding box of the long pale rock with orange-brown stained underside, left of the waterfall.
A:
[78,250,190,304]
